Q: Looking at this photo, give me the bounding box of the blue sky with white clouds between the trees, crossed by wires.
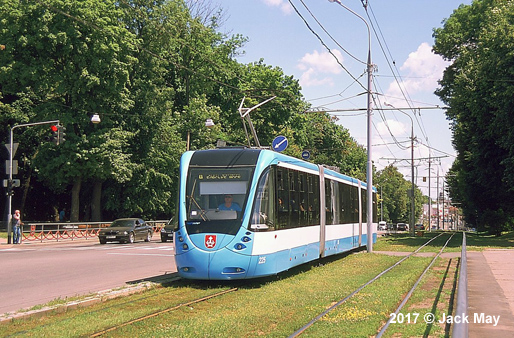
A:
[219,0,472,198]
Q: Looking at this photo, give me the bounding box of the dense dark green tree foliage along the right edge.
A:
[434,0,514,233]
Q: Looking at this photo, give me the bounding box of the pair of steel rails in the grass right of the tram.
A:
[289,233,454,338]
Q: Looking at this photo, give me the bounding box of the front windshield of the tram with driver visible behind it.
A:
[186,167,253,234]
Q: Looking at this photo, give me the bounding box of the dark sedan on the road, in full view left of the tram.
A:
[98,218,153,244]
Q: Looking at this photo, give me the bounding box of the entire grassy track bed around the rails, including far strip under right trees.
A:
[0,233,514,337]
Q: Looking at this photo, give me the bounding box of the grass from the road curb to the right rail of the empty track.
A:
[0,252,440,337]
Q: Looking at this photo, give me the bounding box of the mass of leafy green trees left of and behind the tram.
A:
[0,0,366,221]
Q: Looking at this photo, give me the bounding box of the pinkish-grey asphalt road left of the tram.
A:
[0,235,176,314]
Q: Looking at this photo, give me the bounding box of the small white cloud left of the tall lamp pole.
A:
[297,49,343,88]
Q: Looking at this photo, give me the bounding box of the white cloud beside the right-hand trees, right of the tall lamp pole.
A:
[386,42,449,106]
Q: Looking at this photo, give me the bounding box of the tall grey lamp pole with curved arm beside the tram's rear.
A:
[328,0,373,252]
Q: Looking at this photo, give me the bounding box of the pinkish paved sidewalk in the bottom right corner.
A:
[467,249,514,338]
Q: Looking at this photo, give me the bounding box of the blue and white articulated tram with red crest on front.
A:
[174,148,377,280]
